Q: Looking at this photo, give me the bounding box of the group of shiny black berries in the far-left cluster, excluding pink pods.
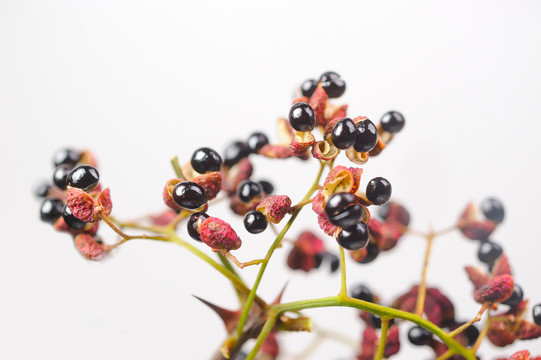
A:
[36,149,100,230]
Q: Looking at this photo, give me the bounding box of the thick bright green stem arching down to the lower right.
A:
[271,296,475,360]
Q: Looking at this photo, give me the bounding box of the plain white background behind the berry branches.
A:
[0,0,541,360]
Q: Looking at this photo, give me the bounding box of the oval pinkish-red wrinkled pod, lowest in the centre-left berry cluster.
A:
[199,216,242,251]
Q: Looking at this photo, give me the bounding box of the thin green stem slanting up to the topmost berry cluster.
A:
[232,162,325,338]
